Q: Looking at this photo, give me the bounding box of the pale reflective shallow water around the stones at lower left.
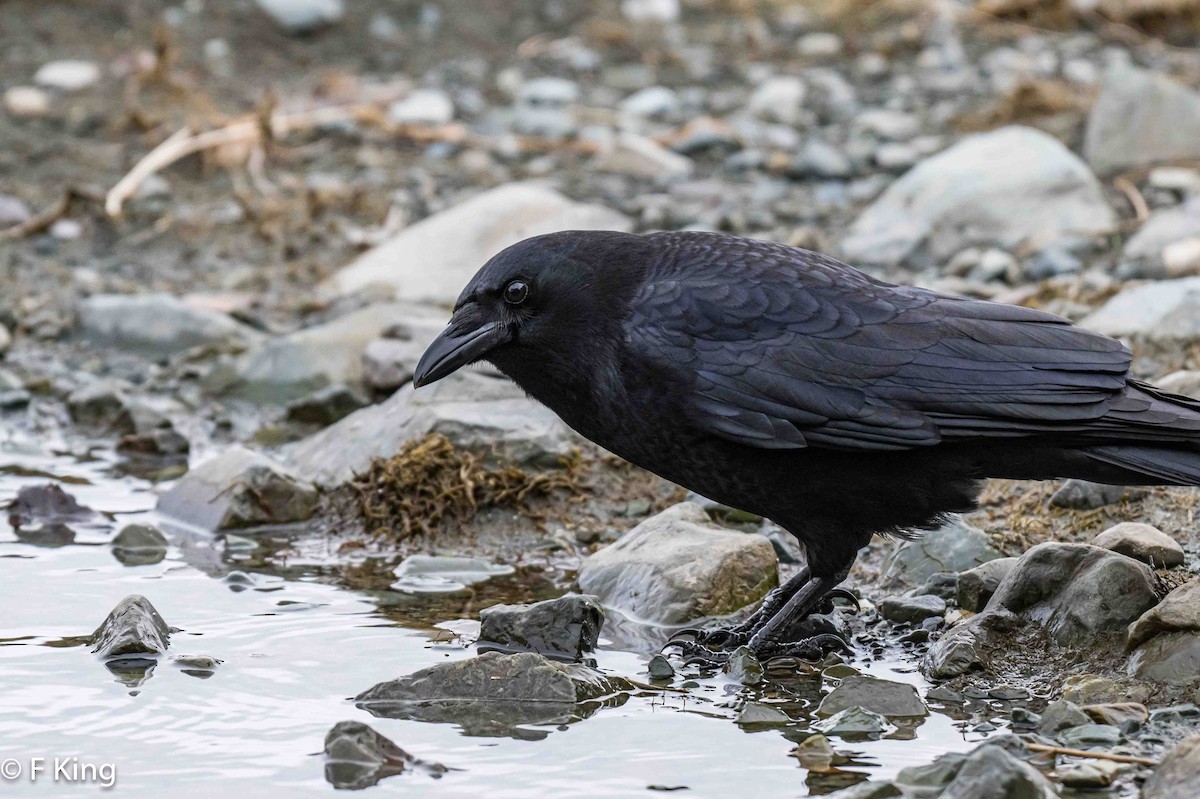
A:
[0,437,980,798]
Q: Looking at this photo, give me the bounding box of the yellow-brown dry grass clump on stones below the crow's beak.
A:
[350,433,582,540]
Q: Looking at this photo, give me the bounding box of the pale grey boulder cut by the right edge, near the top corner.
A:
[1084,64,1200,174]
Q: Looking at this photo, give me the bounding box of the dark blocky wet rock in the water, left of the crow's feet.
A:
[479,594,604,660]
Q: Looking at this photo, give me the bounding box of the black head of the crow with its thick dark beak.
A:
[413,230,646,390]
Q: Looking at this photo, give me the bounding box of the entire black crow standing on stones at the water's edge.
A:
[413,230,1200,662]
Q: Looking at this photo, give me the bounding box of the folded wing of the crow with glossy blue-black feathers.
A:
[625,233,1132,450]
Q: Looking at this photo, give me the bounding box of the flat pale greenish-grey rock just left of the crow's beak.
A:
[226,302,445,403]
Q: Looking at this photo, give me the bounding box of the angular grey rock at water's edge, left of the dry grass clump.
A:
[158,446,318,530]
